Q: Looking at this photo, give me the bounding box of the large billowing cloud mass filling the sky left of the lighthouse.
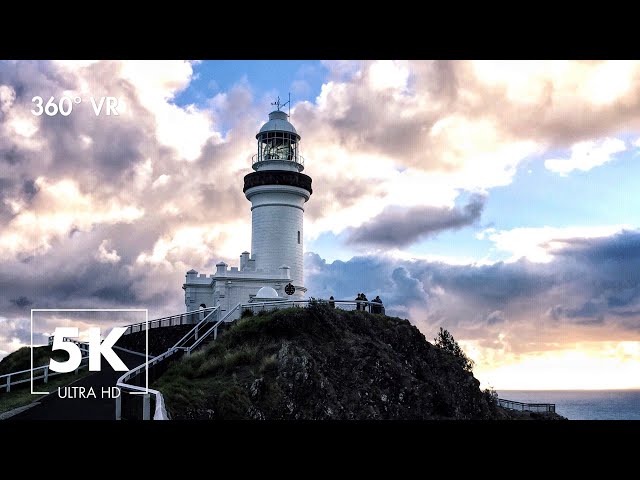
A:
[0,62,258,360]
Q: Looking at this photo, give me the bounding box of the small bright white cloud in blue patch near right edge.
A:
[544,138,627,176]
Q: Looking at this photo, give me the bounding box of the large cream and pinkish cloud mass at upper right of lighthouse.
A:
[292,61,640,235]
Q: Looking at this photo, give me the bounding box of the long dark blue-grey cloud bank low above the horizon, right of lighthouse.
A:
[305,230,640,354]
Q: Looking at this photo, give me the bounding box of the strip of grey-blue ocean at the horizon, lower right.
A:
[498,390,640,420]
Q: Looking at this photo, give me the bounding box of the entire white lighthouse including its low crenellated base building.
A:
[182,104,312,311]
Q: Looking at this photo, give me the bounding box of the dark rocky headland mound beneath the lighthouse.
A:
[154,305,564,420]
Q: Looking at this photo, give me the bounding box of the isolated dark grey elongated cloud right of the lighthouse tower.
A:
[347,195,485,247]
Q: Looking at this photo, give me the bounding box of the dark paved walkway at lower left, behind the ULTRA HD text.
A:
[11,350,144,420]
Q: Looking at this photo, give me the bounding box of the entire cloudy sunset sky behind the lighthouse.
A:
[0,60,640,389]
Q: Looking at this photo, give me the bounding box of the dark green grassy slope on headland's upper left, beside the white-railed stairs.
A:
[153,307,408,419]
